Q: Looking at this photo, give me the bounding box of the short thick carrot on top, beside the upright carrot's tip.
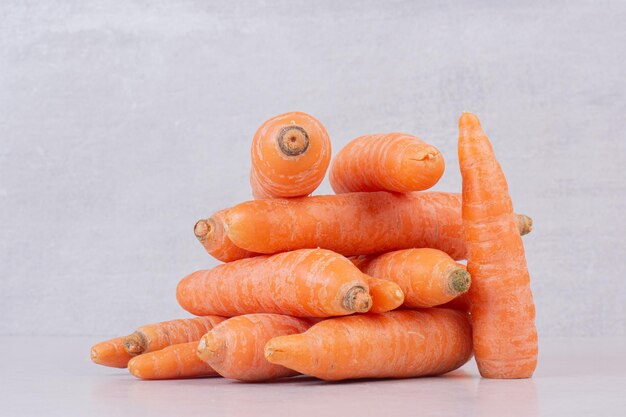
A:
[329,133,445,194]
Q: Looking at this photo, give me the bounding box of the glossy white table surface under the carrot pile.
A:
[0,336,626,417]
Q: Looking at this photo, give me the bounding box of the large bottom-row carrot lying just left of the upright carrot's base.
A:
[265,308,472,381]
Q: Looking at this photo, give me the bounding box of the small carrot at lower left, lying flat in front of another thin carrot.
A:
[128,341,218,379]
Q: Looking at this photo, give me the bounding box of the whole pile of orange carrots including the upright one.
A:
[91,109,537,381]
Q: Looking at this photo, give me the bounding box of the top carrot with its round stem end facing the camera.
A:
[250,112,331,198]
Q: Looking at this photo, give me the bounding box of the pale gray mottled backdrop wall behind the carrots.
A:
[0,0,626,335]
